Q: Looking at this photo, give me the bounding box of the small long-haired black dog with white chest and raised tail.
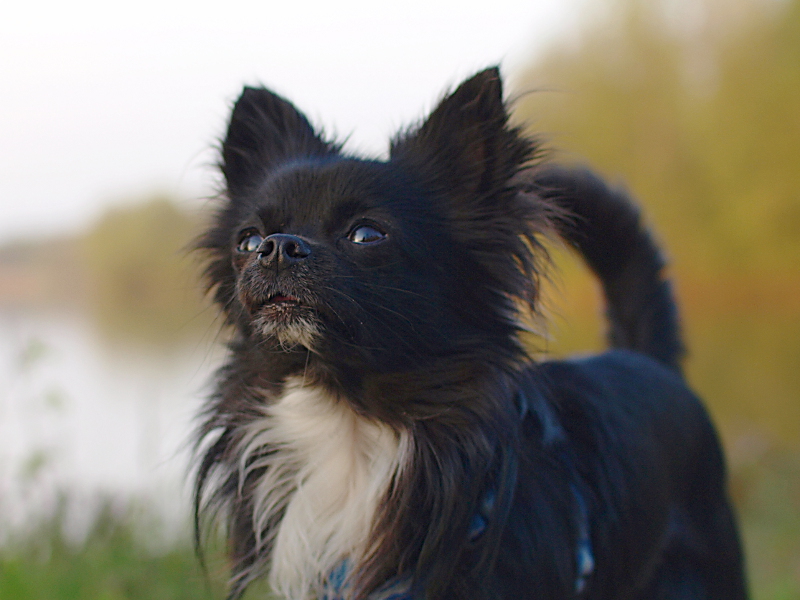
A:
[195,68,747,600]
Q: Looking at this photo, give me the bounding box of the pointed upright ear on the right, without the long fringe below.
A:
[391,67,534,195]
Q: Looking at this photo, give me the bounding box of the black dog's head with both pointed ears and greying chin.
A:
[201,69,546,384]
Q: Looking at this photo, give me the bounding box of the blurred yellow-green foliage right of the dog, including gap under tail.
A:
[514,0,800,600]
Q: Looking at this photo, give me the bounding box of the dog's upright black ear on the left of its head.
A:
[222,87,336,196]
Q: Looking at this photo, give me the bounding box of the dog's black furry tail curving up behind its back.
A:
[533,166,684,372]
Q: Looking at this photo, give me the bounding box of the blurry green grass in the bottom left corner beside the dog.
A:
[0,503,224,600]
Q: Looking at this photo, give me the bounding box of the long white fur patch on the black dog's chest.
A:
[240,380,410,600]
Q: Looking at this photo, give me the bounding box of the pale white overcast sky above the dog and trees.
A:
[0,0,587,244]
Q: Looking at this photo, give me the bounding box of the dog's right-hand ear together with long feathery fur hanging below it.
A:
[391,67,552,312]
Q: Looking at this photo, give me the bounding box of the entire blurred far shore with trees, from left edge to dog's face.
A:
[0,194,216,347]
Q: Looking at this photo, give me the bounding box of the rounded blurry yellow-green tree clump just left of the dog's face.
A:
[81,196,213,343]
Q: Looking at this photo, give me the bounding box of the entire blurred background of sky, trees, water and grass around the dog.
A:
[0,0,800,600]
